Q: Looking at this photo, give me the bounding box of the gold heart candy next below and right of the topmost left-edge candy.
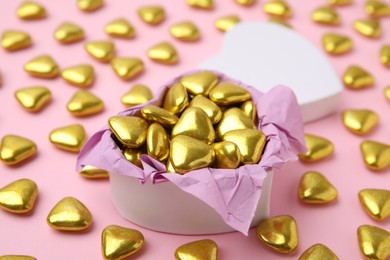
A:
[24,55,60,79]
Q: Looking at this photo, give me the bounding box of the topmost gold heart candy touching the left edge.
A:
[1,30,31,51]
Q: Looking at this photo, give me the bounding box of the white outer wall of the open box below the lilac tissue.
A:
[110,171,273,235]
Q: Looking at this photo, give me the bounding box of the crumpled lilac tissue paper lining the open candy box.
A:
[77,71,306,235]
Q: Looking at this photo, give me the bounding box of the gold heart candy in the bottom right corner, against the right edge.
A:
[357,225,390,260]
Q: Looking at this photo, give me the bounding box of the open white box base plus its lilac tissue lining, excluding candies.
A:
[77,71,306,235]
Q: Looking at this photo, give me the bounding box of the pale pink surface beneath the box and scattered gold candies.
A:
[0,0,390,259]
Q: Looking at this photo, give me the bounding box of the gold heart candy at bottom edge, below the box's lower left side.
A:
[102,225,145,260]
